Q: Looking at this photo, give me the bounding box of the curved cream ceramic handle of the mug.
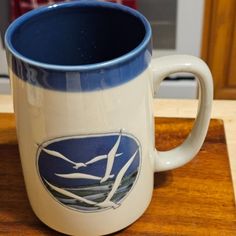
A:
[151,55,213,172]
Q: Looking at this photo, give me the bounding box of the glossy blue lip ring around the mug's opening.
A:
[5,1,151,71]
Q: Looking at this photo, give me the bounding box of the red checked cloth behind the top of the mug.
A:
[11,0,137,20]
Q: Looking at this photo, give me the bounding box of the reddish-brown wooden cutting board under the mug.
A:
[0,114,236,236]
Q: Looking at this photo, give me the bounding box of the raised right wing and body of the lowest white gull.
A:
[97,150,138,208]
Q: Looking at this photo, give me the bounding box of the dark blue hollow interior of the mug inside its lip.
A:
[10,4,146,66]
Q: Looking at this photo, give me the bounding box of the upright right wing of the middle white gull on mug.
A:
[100,132,122,183]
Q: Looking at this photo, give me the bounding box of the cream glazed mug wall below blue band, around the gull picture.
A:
[9,65,154,235]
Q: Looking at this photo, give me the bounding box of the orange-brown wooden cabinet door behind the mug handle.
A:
[202,0,236,99]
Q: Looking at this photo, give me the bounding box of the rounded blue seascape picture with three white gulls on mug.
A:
[37,133,141,211]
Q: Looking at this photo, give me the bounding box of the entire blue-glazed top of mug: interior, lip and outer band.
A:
[5,1,151,91]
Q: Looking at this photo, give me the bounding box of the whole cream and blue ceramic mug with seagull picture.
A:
[5,1,213,236]
